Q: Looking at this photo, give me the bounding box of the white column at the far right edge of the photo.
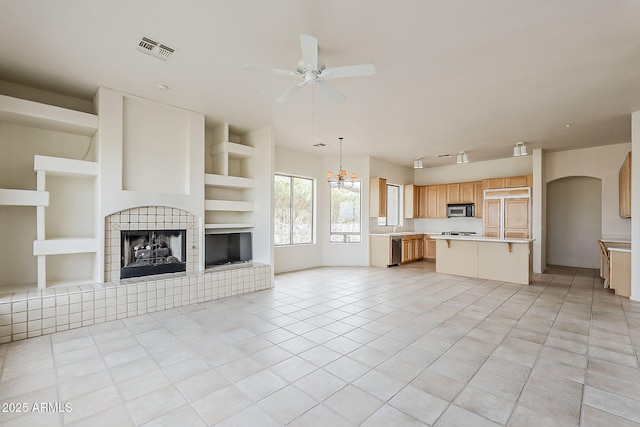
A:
[631,111,640,301]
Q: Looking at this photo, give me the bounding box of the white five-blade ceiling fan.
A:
[244,34,376,103]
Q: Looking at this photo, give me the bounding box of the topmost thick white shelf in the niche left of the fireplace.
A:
[0,95,98,136]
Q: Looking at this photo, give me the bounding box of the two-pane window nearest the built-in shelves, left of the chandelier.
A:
[273,174,314,246]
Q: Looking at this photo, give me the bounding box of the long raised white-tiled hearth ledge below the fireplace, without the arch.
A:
[0,263,272,344]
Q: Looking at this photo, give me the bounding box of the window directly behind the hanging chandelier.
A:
[330,181,361,243]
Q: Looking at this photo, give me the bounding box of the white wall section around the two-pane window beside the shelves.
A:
[274,147,329,273]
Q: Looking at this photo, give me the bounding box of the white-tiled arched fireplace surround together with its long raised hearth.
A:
[0,206,273,344]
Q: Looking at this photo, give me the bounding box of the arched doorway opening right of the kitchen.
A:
[546,176,602,268]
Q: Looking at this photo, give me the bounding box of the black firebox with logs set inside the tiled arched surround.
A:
[120,230,187,279]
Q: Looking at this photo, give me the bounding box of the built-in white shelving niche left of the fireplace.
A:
[0,95,98,294]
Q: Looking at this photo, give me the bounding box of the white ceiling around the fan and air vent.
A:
[0,0,640,166]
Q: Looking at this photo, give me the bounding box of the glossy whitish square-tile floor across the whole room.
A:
[0,262,640,427]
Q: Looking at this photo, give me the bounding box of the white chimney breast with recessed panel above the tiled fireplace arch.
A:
[96,88,205,219]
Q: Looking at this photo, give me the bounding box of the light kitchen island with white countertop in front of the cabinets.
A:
[431,235,533,285]
